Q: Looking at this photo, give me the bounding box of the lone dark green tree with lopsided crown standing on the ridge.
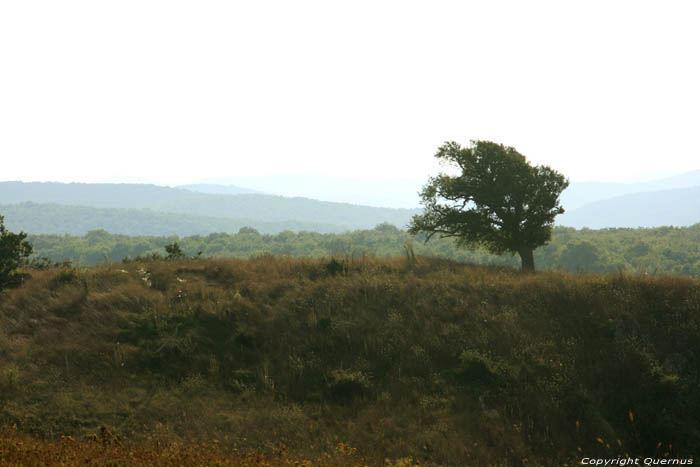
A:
[409,141,569,272]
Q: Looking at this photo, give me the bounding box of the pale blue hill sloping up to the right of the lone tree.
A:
[557,186,700,229]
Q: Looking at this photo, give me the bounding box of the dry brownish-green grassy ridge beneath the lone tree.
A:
[0,257,700,465]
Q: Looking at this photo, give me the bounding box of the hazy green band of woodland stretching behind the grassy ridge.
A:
[28,223,700,277]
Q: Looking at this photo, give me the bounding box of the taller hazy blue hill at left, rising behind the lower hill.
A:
[0,182,419,231]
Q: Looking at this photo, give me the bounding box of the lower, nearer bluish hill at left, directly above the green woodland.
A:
[0,202,347,237]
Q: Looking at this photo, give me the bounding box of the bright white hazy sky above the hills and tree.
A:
[0,0,700,183]
